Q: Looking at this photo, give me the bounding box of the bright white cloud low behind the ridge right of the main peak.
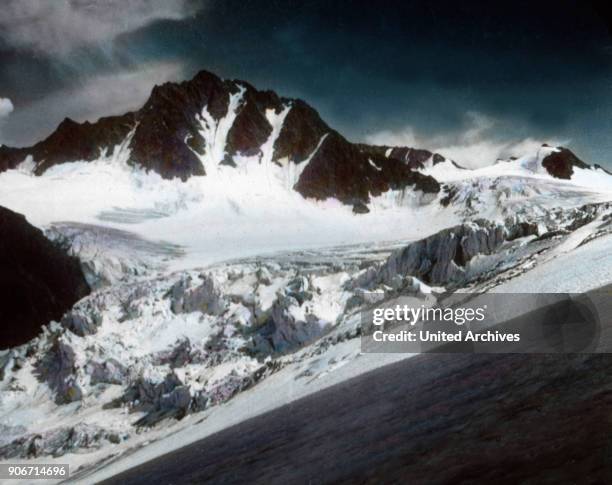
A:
[366,112,569,168]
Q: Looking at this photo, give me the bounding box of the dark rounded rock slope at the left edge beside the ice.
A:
[0,207,89,349]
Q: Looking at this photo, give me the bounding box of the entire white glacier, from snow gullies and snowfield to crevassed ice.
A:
[0,115,612,483]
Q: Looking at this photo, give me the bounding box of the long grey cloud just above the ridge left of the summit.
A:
[0,62,184,146]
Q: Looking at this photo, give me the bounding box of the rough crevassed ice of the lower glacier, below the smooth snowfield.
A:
[0,198,612,476]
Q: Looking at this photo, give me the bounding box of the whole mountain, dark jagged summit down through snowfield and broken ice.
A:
[0,68,612,476]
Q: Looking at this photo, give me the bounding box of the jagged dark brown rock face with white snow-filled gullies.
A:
[0,71,440,205]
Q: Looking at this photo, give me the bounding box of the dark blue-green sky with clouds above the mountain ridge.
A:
[0,0,612,166]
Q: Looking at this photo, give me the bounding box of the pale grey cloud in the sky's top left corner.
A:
[0,0,202,55]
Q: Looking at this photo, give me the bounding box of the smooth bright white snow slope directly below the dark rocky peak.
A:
[0,139,456,269]
